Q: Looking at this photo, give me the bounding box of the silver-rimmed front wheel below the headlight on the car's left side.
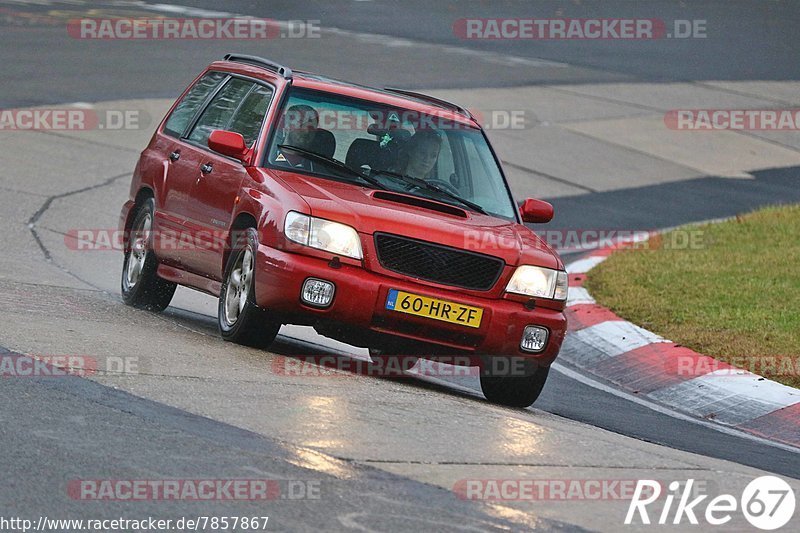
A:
[217,228,281,348]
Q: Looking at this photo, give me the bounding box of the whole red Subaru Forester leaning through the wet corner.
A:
[120,54,567,406]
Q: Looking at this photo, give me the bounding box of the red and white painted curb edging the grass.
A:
[559,248,800,448]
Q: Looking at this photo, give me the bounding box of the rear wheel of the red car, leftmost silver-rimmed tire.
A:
[120,198,177,312]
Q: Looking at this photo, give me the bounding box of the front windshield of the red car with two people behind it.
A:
[267,88,516,220]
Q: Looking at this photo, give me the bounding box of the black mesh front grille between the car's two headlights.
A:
[375,233,505,291]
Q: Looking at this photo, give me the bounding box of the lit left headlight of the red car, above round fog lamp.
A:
[283,211,363,259]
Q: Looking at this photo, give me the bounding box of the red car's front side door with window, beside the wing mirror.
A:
[181,77,274,280]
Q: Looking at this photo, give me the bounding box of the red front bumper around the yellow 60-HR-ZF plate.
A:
[255,245,567,366]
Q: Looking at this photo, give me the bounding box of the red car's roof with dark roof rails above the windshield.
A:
[210,54,480,127]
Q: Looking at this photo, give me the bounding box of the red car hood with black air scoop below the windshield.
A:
[274,171,563,269]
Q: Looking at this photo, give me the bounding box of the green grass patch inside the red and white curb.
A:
[586,205,800,387]
